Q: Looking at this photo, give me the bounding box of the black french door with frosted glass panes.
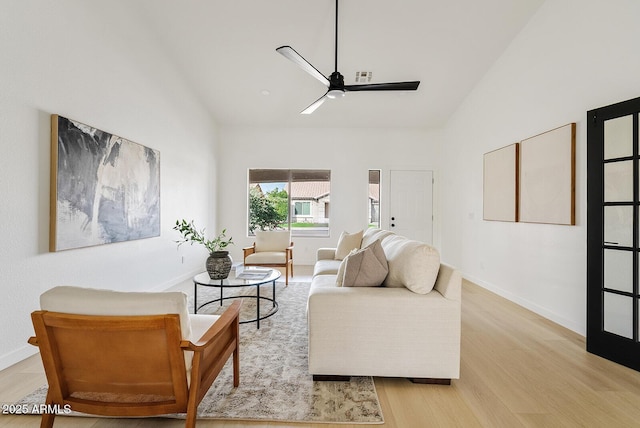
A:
[587,98,640,370]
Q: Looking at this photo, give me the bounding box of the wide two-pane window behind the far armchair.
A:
[248,169,331,236]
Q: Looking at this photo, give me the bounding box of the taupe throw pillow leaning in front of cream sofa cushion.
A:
[338,240,389,287]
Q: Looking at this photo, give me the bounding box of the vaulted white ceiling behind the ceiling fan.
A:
[135,0,544,128]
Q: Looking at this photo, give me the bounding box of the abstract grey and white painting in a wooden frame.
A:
[50,115,160,251]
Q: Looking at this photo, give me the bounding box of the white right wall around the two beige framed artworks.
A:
[441,0,640,334]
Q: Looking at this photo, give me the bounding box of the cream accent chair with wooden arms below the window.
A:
[243,230,293,285]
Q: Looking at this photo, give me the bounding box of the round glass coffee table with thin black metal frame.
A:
[193,269,281,328]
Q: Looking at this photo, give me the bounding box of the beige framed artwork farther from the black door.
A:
[482,143,519,222]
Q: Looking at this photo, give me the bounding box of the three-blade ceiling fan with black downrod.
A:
[276,0,420,114]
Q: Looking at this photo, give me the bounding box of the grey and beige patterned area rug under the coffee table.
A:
[16,283,384,424]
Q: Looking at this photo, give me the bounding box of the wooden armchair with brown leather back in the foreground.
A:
[29,287,241,427]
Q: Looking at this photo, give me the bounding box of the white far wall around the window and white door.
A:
[218,128,442,265]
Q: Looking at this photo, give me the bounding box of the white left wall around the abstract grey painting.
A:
[0,0,217,369]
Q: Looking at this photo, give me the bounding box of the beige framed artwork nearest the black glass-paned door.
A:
[518,123,576,225]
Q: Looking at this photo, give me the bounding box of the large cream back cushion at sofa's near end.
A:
[382,235,440,294]
